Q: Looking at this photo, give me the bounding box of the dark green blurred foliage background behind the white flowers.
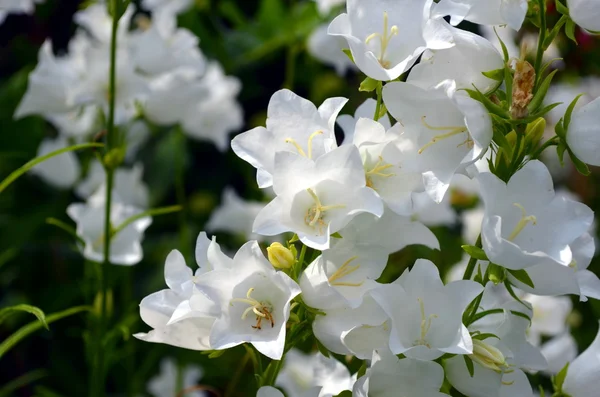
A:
[0,0,600,397]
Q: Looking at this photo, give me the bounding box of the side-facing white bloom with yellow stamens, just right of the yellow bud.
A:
[300,210,439,310]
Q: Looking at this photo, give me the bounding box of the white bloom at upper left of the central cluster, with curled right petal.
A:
[231,90,348,188]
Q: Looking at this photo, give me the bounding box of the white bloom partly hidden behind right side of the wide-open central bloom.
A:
[352,118,424,216]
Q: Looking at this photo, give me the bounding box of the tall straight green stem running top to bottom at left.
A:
[90,0,119,397]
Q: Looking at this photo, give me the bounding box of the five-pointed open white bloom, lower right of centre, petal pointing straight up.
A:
[370,259,483,360]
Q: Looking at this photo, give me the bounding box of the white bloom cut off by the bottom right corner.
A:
[563,322,600,397]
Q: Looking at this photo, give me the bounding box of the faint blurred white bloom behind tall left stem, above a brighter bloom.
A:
[75,161,149,208]
